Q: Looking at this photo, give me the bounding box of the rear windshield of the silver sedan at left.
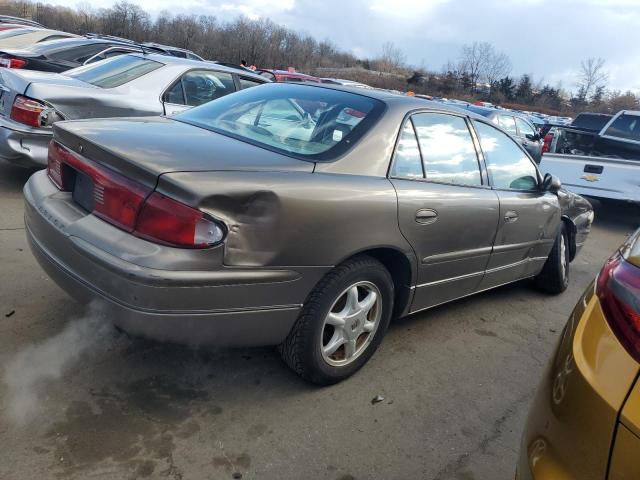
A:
[65,55,163,88]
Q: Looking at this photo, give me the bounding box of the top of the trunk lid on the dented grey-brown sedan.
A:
[53,117,314,188]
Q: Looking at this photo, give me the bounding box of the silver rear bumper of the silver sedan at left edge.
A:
[0,119,51,168]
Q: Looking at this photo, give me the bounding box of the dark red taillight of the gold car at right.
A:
[596,253,640,362]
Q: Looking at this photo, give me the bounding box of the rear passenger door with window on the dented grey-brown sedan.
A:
[389,112,499,312]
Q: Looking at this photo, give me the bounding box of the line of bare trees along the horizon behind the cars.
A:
[0,0,640,114]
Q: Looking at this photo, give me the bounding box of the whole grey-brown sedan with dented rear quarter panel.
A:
[24,84,593,383]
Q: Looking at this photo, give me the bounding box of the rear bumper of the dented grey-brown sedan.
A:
[24,172,324,346]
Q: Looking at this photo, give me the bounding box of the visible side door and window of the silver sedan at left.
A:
[162,70,236,115]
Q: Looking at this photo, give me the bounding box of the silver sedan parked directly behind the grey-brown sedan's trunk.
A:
[0,53,268,167]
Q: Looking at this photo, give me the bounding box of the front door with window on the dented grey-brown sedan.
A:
[473,120,561,289]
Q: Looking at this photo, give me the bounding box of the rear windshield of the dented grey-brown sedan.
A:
[173,84,384,160]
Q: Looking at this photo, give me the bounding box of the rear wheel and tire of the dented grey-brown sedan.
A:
[278,255,394,385]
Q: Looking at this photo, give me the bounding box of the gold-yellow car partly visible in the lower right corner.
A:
[516,230,640,480]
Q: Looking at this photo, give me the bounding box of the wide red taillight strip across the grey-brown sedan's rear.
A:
[47,141,225,248]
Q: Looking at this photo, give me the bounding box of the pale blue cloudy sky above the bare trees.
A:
[48,0,640,93]
